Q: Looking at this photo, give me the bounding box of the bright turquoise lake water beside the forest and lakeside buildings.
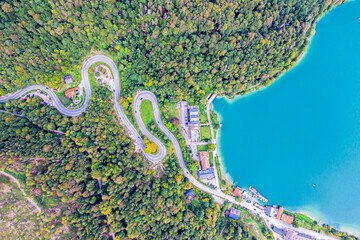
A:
[214,1,360,234]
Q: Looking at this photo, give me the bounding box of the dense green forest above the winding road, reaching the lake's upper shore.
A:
[0,0,345,101]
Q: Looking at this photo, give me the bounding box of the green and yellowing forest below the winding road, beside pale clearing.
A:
[0,84,271,239]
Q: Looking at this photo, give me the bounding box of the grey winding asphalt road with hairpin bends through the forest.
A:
[0,55,334,239]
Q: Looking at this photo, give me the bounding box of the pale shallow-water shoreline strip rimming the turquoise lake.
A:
[212,0,360,236]
